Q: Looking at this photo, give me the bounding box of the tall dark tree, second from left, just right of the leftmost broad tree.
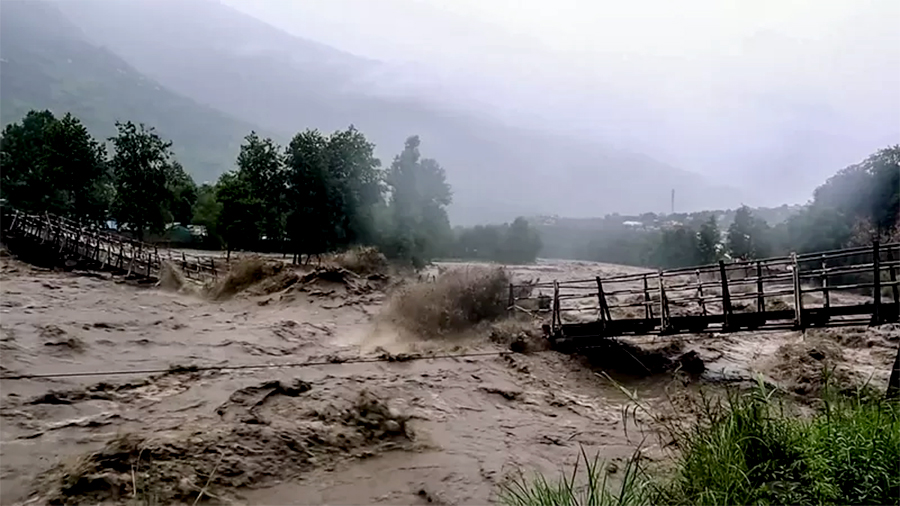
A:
[109,121,176,240]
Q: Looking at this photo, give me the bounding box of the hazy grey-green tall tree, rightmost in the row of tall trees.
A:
[386,136,452,266]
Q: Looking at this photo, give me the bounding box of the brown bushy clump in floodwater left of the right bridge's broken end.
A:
[390,267,510,337]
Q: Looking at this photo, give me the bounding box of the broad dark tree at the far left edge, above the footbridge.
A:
[0,111,111,223]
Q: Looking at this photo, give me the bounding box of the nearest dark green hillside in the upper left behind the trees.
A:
[0,0,259,181]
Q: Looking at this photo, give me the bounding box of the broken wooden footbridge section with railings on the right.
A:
[509,242,900,347]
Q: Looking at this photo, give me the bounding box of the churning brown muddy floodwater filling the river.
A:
[0,257,900,504]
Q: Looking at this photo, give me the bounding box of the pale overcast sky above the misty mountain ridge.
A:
[222,0,900,205]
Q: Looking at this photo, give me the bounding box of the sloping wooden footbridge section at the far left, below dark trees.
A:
[0,208,228,280]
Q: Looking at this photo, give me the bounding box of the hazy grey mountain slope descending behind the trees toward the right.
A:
[3,0,739,223]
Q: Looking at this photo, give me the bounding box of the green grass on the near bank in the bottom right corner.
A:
[499,386,900,506]
